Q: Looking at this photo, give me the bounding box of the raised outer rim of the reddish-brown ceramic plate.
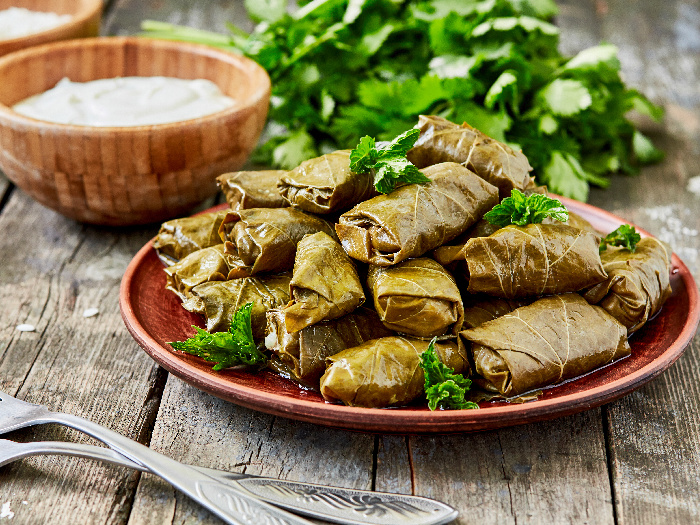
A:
[119,196,700,434]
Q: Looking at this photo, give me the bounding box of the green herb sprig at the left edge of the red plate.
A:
[168,303,267,371]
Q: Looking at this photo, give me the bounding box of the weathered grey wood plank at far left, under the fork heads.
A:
[0,191,164,524]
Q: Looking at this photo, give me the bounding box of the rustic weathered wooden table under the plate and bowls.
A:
[0,0,700,525]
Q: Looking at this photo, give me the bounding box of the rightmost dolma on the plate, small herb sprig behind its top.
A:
[583,237,671,333]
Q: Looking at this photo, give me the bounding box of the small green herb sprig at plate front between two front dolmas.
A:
[420,338,479,410]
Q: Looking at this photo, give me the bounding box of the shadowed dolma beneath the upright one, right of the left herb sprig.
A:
[265,307,392,388]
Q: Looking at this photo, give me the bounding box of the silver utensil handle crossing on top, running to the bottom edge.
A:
[45,412,313,525]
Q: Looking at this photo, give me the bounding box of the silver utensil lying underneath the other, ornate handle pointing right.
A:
[0,439,457,525]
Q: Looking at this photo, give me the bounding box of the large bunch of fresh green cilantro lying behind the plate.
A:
[144,0,662,200]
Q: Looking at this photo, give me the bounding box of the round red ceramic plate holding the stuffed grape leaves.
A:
[120,199,700,433]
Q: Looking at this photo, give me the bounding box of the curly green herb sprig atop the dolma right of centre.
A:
[484,189,569,226]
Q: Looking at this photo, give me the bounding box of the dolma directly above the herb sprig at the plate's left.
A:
[182,273,291,342]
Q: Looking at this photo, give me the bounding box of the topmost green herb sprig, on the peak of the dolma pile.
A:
[350,129,430,193]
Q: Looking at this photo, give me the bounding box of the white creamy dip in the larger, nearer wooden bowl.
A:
[12,77,235,127]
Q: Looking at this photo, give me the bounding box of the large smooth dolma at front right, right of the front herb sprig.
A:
[460,293,630,397]
